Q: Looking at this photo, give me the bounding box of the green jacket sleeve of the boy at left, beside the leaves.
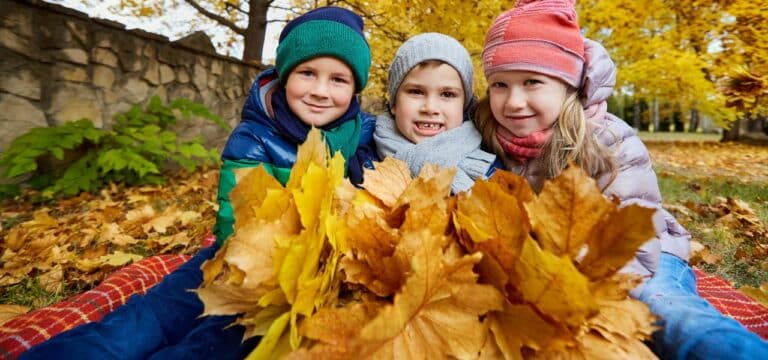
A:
[213,160,291,246]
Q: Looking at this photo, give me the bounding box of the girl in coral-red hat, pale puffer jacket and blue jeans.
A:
[475,0,768,359]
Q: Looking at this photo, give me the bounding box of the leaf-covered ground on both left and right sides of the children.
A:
[0,137,768,316]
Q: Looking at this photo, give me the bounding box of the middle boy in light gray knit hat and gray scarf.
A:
[373,33,496,193]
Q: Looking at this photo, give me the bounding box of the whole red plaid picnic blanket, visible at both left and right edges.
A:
[0,255,768,359]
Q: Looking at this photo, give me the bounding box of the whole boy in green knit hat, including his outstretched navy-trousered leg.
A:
[21,7,375,359]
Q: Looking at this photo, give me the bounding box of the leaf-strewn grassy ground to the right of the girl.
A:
[646,141,768,306]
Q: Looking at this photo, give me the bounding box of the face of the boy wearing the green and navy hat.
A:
[285,56,355,127]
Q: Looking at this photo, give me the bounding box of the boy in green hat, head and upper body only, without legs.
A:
[214,7,376,245]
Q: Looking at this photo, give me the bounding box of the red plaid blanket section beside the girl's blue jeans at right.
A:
[694,268,768,340]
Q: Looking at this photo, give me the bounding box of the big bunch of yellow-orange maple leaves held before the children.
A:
[197,131,654,359]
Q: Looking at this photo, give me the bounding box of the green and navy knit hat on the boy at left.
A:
[275,6,371,92]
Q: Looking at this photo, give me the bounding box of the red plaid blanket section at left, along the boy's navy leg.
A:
[0,255,190,359]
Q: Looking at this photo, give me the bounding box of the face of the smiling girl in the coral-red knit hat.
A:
[488,70,568,137]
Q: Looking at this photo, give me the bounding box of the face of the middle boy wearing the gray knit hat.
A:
[392,62,464,144]
